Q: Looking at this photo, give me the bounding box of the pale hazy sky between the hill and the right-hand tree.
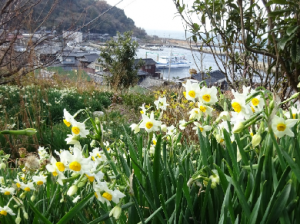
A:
[106,0,184,31]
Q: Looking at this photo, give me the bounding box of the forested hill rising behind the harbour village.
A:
[31,0,146,37]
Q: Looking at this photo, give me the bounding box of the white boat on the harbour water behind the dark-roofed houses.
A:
[156,56,191,68]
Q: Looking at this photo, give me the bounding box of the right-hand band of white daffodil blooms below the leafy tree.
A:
[131,80,300,161]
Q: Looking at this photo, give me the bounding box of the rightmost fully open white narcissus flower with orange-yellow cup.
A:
[272,115,298,138]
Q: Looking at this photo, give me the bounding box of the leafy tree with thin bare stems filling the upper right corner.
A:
[173,0,300,97]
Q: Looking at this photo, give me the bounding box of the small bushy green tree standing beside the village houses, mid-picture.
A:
[100,32,141,89]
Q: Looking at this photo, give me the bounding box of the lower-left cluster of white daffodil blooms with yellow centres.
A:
[0,110,127,223]
